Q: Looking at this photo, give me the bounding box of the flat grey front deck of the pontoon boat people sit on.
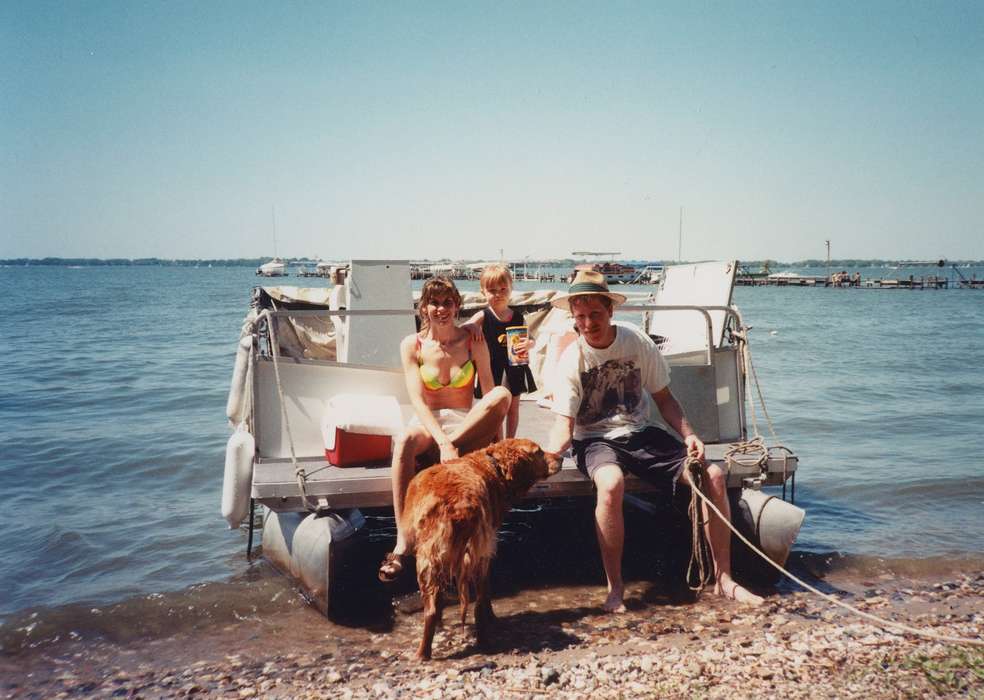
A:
[252,400,797,511]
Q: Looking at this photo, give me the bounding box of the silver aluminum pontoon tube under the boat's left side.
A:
[263,508,366,615]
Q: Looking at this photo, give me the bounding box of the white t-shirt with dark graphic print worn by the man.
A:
[553,324,670,440]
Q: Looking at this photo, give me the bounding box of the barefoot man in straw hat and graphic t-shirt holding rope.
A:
[547,270,762,613]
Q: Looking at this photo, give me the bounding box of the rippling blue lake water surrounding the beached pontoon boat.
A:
[0,267,984,636]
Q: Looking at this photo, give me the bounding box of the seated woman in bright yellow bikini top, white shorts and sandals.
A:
[379,277,512,581]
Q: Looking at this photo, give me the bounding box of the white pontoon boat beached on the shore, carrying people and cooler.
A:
[222,260,803,613]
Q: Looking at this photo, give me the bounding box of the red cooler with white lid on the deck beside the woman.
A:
[321,394,403,467]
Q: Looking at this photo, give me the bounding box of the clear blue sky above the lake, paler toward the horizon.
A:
[0,0,984,261]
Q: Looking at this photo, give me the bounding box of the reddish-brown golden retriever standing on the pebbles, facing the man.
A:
[402,438,560,660]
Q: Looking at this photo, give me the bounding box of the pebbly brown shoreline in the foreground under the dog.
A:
[0,574,984,699]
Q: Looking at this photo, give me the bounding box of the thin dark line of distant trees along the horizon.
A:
[0,258,984,270]
